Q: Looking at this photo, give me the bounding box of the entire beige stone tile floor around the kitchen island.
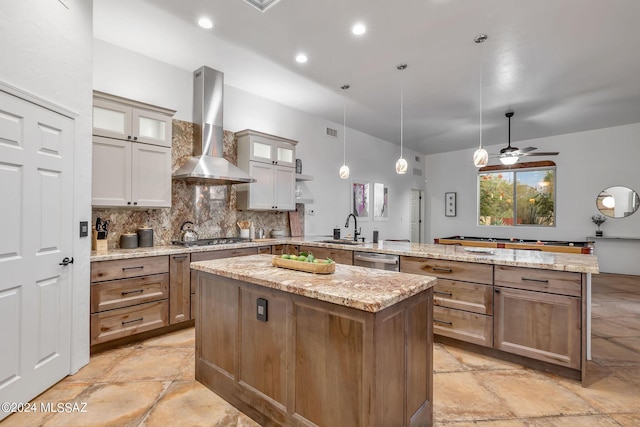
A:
[0,274,640,427]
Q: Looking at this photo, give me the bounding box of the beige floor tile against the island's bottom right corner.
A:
[433,372,513,422]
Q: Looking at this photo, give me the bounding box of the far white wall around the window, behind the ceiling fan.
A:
[425,123,640,274]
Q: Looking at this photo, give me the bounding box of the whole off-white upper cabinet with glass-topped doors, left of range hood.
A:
[91,92,173,208]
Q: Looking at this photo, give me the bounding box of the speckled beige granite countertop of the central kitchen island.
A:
[191,254,436,313]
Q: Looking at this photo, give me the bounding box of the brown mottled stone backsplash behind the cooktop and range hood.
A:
[92,120,304,249]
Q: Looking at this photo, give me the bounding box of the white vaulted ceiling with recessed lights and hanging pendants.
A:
[94,0,640,154]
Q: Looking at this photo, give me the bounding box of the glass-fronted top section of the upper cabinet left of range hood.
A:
[93,91,175,148]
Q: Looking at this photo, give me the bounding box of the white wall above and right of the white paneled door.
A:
[0,0,93,371]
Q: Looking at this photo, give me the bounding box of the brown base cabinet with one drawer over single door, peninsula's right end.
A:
[494,266,583,369]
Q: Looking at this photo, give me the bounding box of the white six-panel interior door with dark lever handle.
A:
[0,92,74,419]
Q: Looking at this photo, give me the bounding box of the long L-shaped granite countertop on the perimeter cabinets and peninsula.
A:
[91,236,599,273]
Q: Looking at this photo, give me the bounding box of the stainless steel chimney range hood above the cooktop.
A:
[173,67,255,185]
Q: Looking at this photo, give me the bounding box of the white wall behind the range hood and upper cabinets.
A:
[94,40,424,244]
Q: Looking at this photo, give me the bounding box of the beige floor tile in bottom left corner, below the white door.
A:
[0,382,91,427]
